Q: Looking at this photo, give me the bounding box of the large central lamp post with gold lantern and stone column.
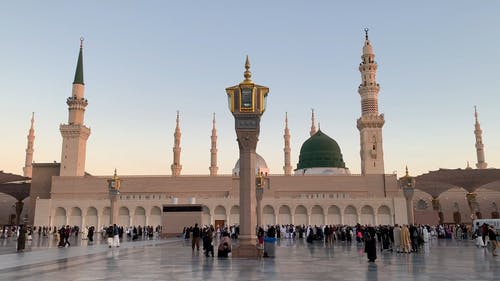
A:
[226,56,269,257]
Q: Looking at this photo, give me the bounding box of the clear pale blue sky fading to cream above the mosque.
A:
[0,0,500,176]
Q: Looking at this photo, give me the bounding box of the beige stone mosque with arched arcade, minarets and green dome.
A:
[1,30,500,228]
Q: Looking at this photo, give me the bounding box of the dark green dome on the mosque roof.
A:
[297,130,345,170]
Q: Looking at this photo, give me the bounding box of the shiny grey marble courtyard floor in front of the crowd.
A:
[0,235,500,281]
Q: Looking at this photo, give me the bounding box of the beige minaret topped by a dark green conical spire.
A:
[59,38,90,177]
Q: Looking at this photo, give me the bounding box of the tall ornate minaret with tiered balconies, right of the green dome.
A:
[357,28,385,174]
